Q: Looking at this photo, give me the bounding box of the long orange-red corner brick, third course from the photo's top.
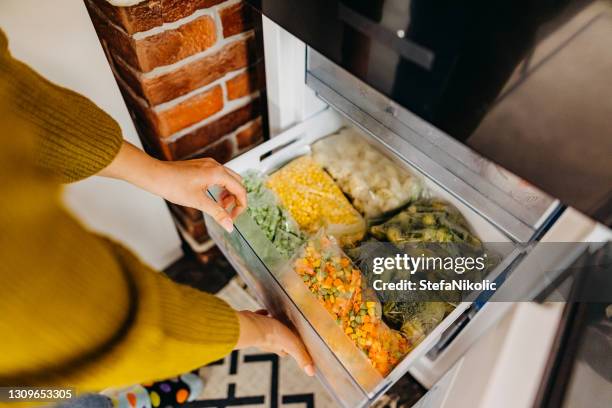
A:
[117,37,254,105]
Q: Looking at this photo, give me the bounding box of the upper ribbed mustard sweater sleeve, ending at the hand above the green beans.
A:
[0,30,123,183]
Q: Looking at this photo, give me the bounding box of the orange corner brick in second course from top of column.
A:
[90,6,217,72]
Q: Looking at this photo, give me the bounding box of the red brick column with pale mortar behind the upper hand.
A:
[84,0,265,258]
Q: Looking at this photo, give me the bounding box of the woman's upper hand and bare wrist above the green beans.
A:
[100,142,247,232]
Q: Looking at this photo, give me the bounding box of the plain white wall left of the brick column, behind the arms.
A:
[0,0,181,268]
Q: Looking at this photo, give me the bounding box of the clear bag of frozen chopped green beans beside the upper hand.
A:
[244,171,305,258]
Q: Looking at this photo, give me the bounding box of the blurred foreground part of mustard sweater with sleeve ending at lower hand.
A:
[0,99,239,388]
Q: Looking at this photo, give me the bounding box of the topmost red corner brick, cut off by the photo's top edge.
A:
[86,0,224,34]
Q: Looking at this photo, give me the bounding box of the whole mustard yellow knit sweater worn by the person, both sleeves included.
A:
[0,30,239,390]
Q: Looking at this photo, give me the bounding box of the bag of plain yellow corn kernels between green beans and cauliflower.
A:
[266,156,366,245]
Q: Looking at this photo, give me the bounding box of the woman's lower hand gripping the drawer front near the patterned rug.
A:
[236,310,314,376]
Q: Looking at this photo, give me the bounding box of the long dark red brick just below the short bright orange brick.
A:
[167,100,260,160]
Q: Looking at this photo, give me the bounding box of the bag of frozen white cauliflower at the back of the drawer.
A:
[312,128,423,219]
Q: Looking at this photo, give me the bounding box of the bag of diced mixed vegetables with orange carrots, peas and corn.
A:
[293,232,411,376]
